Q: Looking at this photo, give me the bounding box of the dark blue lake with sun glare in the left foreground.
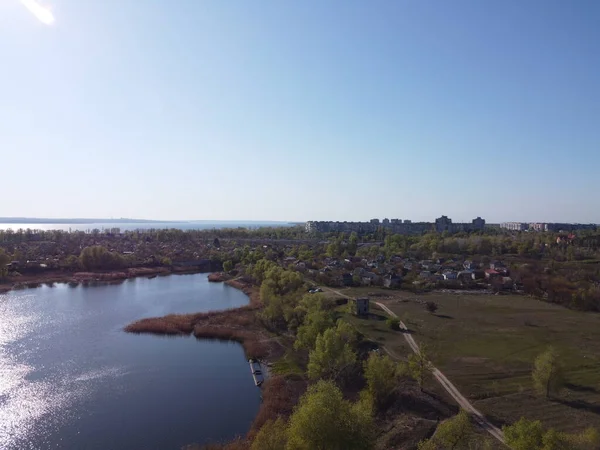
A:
[0,274,260,450]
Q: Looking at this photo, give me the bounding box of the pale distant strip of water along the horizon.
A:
[0,221,290,231]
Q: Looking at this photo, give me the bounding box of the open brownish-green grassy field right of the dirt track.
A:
[332,288,600,431]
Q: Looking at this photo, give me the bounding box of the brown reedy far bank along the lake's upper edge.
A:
[0,267,207,294]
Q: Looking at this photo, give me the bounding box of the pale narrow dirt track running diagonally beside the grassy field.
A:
[323,287,505,444]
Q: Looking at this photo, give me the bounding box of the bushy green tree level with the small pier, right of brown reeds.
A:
[308,321,356,380]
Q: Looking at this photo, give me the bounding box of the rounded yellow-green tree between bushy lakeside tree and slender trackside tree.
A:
[364,352,399,408]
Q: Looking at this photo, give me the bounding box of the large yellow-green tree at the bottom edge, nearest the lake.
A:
[286,380,373,450]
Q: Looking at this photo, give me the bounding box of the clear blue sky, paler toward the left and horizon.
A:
[0,0,600,222]
